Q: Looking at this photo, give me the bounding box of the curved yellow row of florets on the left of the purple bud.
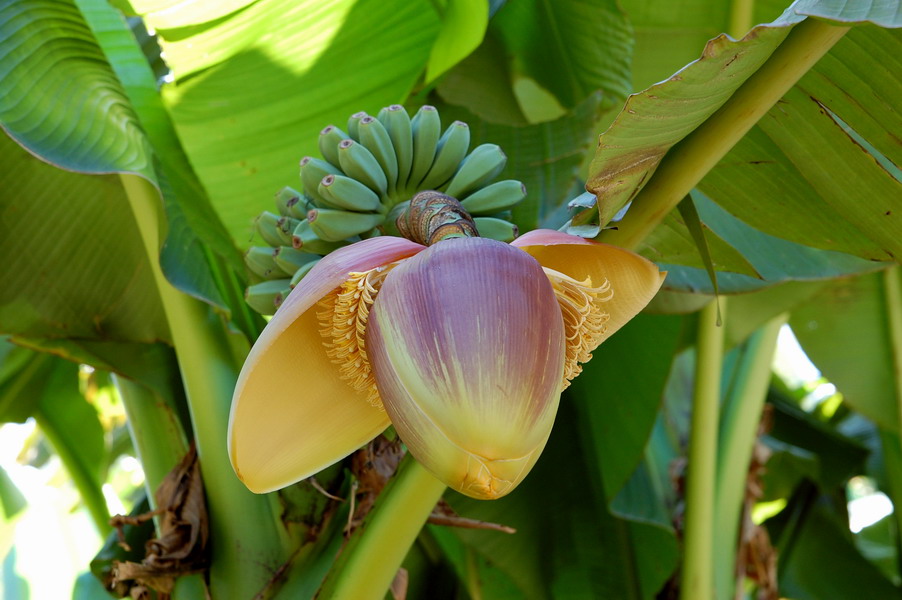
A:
[316,264,394,409]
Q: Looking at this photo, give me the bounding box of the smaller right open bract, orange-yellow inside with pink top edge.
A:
[511,229,667,341]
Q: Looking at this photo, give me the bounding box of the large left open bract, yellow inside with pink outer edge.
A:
[229,237,424,493]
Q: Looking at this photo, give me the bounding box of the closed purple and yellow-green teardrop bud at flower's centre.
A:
[366,238,564,498]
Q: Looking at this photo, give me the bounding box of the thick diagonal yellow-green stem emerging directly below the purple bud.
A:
[317,454,445,600]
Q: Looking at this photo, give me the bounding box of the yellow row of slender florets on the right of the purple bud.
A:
[543,267,614,389]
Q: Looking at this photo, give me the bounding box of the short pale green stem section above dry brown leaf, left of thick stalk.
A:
[113,375,188,509]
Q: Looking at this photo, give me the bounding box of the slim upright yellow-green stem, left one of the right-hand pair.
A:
[680,298,727,600]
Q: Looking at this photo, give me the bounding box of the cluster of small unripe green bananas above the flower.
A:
[245,104,526,314]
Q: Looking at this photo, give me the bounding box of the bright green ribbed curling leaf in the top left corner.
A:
[0,0,154,179]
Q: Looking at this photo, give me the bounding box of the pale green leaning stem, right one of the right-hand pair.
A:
[713,314,789,598]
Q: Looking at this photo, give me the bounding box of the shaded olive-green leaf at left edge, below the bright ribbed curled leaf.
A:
[0,133,169,342]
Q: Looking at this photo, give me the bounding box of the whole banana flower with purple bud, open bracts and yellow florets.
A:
[229,230,664,499]
